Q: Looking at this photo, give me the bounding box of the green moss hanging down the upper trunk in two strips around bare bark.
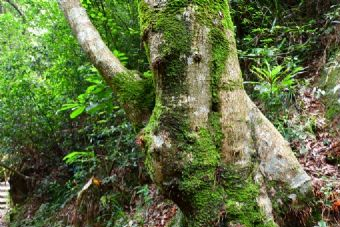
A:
[139,0,233,103]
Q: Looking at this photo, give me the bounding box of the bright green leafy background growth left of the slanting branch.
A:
[0,0,144,213]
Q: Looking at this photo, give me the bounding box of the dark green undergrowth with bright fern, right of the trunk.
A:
[231,0,338,125]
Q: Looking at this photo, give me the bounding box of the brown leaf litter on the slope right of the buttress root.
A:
[291,85,340,226]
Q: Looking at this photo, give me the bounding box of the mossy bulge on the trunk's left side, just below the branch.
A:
[143,98,188,184]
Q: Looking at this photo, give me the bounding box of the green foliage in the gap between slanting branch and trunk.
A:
[82,0,148,72]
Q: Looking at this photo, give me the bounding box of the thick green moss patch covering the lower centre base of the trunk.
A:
[180,129,274,227]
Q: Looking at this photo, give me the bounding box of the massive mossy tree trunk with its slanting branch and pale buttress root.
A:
[60,0,311,227]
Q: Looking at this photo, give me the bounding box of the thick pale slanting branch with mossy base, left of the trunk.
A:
[58,0,154,126]
